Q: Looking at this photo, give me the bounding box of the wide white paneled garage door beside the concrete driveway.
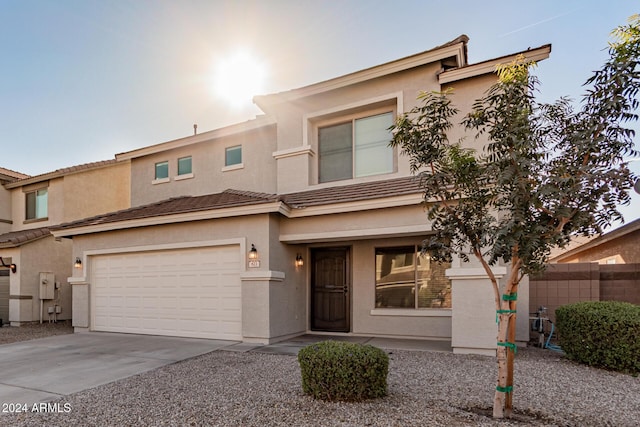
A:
[91,246,242,340]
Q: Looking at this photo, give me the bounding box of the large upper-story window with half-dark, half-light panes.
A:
[318,112,393,182]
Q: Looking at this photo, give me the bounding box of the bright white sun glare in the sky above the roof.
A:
[214,51,265,108]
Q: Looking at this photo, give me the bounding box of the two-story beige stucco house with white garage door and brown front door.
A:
[53,36,551,354]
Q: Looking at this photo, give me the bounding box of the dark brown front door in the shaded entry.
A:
[311,248,350,332]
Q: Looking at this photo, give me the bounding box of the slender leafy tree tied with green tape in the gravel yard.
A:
[391,15,640,418]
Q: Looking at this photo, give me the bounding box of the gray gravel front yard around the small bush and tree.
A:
[0,328,640,426]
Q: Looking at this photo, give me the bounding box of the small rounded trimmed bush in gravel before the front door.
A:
[298,341,389,401]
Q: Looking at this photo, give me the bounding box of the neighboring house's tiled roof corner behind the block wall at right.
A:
[550,218,640,264]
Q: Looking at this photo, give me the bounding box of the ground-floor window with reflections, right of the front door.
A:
[376,246,451,308]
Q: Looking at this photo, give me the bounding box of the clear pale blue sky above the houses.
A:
[0,0,640,221]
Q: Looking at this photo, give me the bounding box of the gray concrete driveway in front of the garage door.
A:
[0,332,236,405]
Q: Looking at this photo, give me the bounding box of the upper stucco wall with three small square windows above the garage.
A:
[131,125,276,206]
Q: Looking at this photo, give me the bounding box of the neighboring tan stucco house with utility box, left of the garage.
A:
[0,160,130,326]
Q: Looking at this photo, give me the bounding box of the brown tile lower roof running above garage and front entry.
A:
[51,177,422,230]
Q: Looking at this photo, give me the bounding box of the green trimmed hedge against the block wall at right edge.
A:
[556,301,640,374]
